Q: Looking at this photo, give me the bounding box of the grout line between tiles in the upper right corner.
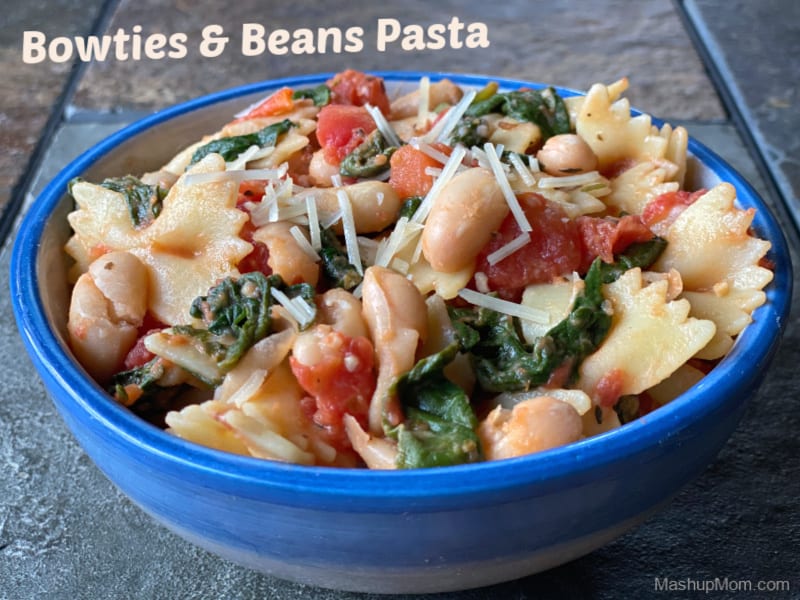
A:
[673,0,800,239]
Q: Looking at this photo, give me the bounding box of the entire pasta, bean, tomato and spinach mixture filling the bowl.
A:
[66,71,772,469]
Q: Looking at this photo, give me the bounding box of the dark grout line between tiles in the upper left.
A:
[0,0,119,246]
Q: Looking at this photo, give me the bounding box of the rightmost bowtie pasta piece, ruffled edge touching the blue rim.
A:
[653,183,773,295]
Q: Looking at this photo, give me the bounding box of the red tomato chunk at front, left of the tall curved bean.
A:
[289,328,376,448]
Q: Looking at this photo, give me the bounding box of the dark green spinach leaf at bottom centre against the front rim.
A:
[388,343,481,469]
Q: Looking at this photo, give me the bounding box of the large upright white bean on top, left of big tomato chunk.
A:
[422,168,509,273]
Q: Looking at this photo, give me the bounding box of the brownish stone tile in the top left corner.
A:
[0,0,101,211]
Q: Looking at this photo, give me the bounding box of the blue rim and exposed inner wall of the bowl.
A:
[12,73,792,502]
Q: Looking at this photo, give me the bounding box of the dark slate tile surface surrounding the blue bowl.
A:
[0,0,800,600]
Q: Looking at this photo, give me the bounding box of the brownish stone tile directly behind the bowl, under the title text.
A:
[74,0,725,119]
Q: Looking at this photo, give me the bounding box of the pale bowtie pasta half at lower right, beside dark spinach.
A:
[578,268,716,397]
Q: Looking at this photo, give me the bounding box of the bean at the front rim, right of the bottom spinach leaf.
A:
[478,396,583,460]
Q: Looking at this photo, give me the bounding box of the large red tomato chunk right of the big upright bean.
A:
[475,193,581,301]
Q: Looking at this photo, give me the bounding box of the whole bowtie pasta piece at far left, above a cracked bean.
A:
[67,154,252,325]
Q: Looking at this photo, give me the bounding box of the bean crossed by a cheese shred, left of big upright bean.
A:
[310,181,402,234]
